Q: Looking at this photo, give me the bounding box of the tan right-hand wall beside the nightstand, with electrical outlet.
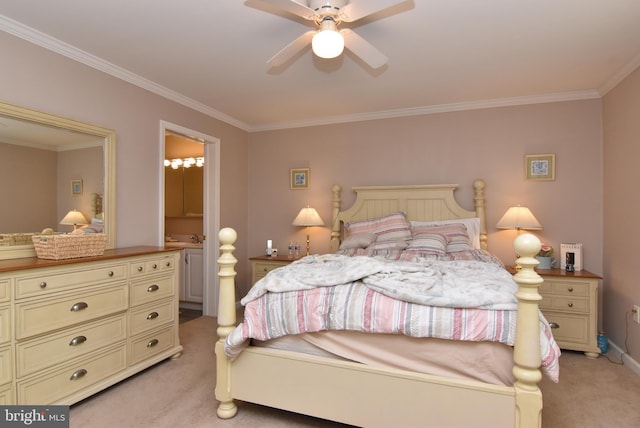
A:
[603,66,640,361]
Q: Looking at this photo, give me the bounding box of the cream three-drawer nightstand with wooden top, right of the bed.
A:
[509,269,602,358]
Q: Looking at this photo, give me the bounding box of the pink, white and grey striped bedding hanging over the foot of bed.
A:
[225,256,560,382]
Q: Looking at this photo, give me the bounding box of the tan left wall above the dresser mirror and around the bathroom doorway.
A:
[0,32,247,286]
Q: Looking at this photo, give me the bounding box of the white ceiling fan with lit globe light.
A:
[255,0,405,68]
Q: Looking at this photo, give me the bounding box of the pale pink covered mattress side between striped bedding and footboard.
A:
[251,331,515,386]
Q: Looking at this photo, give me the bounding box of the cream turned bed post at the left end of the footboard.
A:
[215,227,238,419]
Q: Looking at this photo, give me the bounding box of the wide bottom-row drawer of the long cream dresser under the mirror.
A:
[17,344,127,405]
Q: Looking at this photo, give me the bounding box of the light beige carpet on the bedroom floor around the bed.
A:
[70,317,640,428]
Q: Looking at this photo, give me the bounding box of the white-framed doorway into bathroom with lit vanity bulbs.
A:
[159,121,220,318]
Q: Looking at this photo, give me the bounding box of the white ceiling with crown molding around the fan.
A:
[0,0,640,131]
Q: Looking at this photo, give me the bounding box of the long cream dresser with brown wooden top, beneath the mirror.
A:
[0,247,182,405]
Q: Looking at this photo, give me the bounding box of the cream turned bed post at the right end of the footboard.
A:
[513,233,543,428]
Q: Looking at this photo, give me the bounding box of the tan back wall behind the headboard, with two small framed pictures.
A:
[249,100,602,280]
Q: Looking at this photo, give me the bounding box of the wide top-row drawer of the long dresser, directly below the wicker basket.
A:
[15,263,127,299]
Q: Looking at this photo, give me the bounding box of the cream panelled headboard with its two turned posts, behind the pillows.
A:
[331,180,487,253]
